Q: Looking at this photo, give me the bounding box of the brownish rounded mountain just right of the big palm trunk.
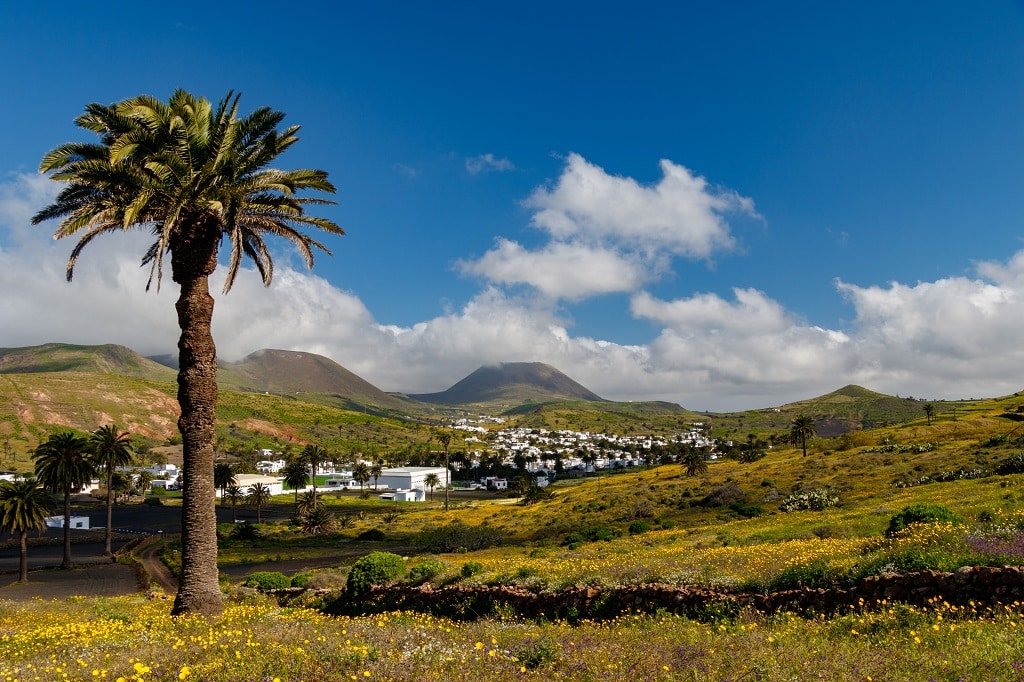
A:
[217,348,402,408]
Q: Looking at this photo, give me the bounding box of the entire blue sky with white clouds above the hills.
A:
[0,2,1024,411]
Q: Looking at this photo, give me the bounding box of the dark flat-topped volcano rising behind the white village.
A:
[410,363,604,406]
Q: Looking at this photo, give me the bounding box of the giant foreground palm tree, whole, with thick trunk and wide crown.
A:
[33,90,344,615]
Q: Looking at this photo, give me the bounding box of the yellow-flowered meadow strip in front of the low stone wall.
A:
[0,596,1024,682]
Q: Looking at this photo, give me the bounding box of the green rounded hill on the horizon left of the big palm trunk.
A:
[0,343,177,381]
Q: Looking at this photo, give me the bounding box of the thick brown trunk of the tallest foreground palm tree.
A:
[171,228,223,615]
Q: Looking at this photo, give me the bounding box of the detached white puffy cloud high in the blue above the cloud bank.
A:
[460,154,757,300]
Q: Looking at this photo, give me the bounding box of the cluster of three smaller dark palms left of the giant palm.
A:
[0,424,134,583]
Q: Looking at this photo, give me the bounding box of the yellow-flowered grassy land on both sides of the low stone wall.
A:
[0,387,1024,681]
